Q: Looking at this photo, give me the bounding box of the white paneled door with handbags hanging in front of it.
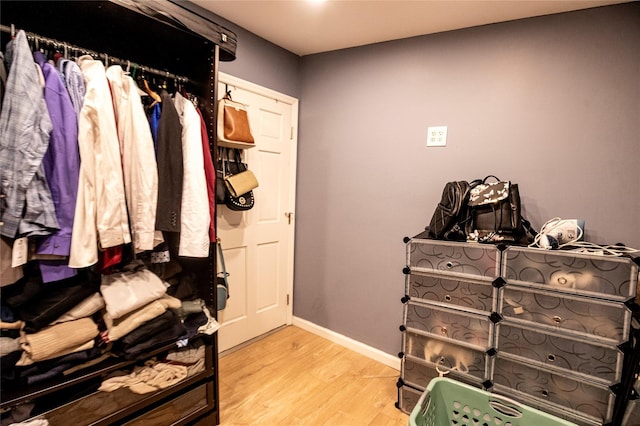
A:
[216,73,298,351]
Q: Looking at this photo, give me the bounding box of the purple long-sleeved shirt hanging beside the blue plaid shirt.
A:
[33,52,80,282]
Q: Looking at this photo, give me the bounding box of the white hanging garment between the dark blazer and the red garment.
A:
[174,93,209,257]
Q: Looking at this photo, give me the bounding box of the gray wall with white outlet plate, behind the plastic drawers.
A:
[294,3,640,354]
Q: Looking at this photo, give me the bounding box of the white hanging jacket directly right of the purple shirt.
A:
[69,55,131,268]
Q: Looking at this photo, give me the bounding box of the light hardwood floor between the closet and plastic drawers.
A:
[219,326,409,426]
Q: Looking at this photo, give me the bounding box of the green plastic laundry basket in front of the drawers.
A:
[409,377,575,426]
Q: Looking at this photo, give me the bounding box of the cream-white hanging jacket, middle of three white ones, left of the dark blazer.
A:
[106,65,164,253]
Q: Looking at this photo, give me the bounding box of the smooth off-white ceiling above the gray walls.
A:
[191,0,631,56]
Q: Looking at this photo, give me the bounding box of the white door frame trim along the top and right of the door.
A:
[218,72,299,325]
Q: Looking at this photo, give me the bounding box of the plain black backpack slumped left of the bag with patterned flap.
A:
[427,180,475,241]
